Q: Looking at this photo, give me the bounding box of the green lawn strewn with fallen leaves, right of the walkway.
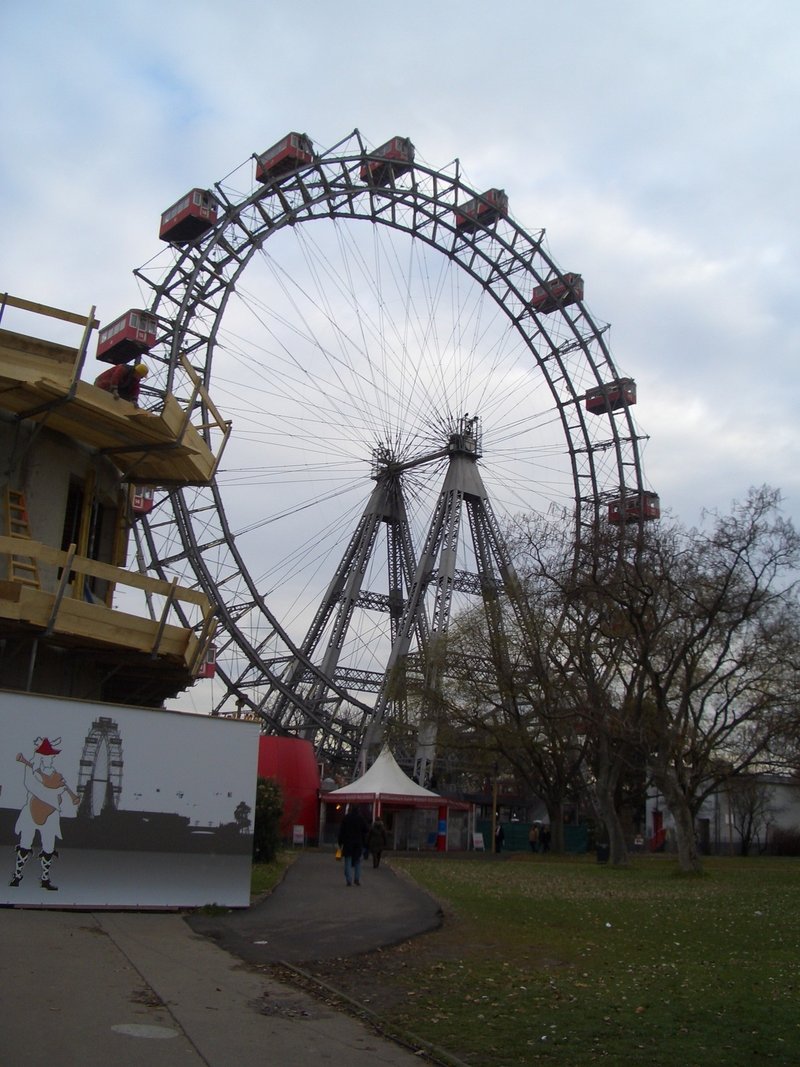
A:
[381,854,800,1067]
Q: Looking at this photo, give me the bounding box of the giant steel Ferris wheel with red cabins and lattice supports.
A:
[130,130,658,765]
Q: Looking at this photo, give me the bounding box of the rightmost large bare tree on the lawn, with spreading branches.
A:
[571,488,800,872]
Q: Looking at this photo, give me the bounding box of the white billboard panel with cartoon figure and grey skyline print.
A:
[0,692,260,908]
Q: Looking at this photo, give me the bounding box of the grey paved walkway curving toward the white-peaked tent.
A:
[0,851,439,1067]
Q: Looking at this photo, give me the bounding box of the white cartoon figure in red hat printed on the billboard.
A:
[10,737,80,892]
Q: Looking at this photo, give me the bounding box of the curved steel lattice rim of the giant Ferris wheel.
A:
[128,131,644,759]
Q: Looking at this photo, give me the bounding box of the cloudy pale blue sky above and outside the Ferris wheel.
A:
[0,0,800,533]
